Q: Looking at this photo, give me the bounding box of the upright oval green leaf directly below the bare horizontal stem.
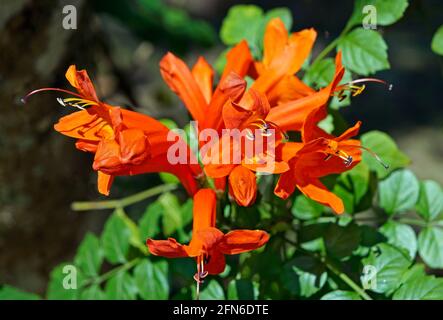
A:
[101,213,131,264]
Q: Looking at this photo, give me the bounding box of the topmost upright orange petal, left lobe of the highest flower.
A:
[263,18,288,67]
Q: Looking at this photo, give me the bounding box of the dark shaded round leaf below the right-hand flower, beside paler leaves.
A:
[324,223,361,258]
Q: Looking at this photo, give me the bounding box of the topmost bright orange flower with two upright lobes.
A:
[251,18,317,106]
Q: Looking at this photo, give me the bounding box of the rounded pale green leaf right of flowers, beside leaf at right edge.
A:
[378,169,420,215]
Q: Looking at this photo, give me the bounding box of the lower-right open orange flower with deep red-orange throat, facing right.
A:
[274,107,362,214]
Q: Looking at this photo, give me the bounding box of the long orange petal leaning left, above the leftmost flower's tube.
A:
[160,52,207,122]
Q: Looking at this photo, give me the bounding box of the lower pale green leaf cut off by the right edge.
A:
[418,227,443,269]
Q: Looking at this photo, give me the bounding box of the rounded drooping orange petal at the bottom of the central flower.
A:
[229,165,257,207]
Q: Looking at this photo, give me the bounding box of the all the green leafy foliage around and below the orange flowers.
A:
[0,0,443,300]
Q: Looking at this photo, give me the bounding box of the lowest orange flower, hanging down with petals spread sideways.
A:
[146,189,269,282]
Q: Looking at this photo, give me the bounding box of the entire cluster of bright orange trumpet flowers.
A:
[25,18,386,283]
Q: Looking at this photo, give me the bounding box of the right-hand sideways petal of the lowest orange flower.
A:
[218,230,269,254]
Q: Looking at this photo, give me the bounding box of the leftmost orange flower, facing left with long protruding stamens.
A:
[25,65,201,195]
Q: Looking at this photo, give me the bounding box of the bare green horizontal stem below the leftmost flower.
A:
[71,184,177,211]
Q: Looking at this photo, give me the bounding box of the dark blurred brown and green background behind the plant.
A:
[0,0,443,293]
